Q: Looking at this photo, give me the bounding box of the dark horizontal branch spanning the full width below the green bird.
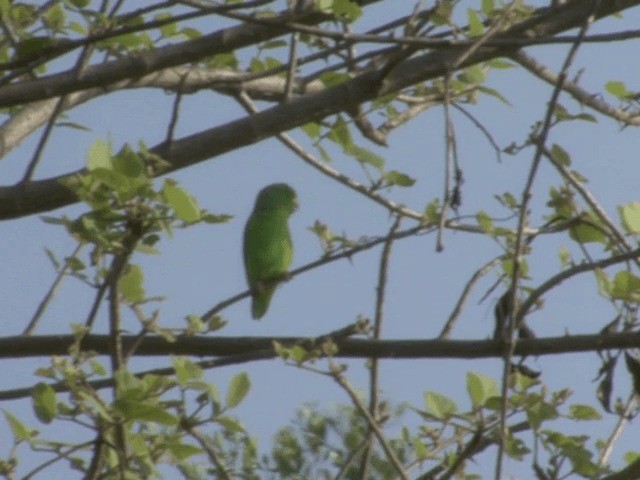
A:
[0,332,640,359]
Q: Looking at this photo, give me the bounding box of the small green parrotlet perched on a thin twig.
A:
[243,183,298,319]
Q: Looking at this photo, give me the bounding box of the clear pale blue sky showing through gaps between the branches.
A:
[0,1,640,478]
